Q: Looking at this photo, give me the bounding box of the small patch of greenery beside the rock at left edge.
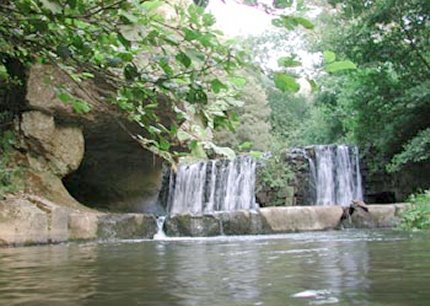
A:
[0,131,22,199]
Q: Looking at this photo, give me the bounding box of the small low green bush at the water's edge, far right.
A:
[400,190,430,230]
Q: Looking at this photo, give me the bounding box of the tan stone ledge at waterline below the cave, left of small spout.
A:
[0,195,157,246]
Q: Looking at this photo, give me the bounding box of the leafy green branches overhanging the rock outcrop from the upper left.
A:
[0,0,252,162]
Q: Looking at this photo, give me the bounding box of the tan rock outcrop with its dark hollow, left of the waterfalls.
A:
[6,65,165,214]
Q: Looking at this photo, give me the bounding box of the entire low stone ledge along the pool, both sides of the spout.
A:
[0,195,406,247]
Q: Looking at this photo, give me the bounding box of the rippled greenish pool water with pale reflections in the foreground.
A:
[0,231,430,305]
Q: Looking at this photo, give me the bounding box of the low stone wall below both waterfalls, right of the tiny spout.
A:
[164,204,407,237]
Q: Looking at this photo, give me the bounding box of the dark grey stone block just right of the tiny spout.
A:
[164,214,221,237]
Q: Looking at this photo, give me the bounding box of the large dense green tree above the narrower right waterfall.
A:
[311,0,430,175]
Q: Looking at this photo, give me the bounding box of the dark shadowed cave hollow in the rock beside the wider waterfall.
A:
[63,123,163,214]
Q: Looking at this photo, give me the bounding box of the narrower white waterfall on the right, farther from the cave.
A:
[310,145,363,206]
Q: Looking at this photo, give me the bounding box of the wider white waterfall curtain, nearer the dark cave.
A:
[163,156,257,215]
